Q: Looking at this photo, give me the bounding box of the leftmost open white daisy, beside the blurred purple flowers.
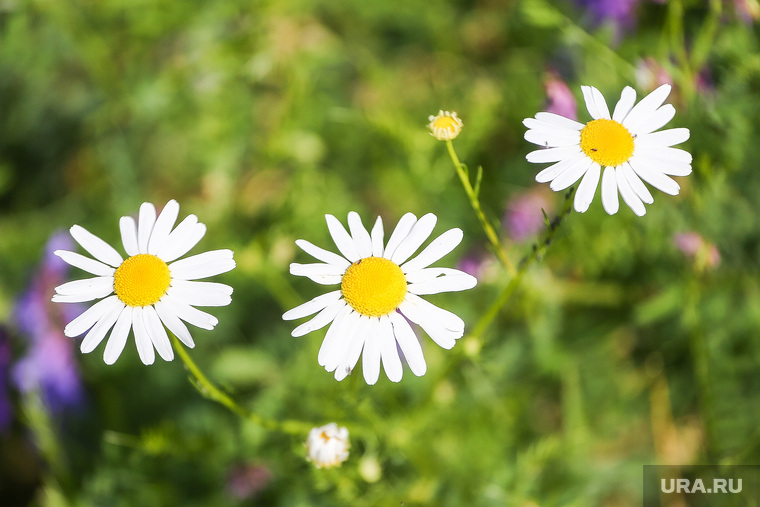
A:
[53,200,235,364]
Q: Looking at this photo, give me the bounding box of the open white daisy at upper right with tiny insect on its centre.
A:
[523,84,691,216]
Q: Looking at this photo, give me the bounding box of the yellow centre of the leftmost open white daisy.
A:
[113,254,171,306]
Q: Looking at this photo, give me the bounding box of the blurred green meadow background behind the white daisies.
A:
[0,0,760,507]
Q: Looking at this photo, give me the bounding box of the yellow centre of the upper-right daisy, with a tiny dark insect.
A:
[581,119,634,167]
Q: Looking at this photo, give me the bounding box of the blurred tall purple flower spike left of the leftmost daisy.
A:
[11,232,83,412]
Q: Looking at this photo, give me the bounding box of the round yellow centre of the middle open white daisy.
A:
[340,257,406,317]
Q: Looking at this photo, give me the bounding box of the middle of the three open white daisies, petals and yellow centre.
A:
[282,211,477,385]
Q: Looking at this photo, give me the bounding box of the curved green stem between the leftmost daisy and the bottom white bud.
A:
[169,333,312,435]
